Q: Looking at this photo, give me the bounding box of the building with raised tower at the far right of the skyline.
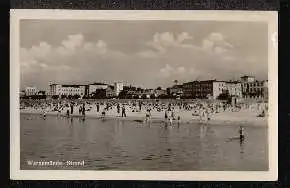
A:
[241,76,268,99]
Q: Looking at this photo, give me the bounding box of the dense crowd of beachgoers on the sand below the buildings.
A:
[20,100,268,124]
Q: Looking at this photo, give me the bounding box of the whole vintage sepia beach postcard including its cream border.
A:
[10,10,278,181]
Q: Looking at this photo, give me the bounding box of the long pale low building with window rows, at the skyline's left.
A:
[49,84,86,97]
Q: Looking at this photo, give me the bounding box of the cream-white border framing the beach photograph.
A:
[10,9,278,181]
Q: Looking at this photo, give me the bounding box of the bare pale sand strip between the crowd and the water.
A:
[20,107,268,127]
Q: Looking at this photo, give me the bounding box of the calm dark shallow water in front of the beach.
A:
[20,115,268,171]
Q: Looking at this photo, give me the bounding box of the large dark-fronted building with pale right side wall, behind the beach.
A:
[183,80,227,99]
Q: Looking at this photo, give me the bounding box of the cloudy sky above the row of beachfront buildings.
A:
[20,20,268,89]
